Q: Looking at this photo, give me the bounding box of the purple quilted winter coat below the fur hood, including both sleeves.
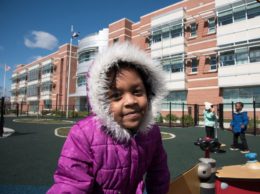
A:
[47,116,170,194]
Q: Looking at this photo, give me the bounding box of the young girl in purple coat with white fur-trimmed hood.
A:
[47,43,170,194]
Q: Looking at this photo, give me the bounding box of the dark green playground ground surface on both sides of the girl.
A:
[0,117,260,194]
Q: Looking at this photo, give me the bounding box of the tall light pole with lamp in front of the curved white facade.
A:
[66,25,79,118]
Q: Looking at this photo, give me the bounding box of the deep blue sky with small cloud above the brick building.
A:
[0,0,179,95]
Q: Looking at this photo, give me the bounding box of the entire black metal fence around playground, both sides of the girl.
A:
[1,101,260,135]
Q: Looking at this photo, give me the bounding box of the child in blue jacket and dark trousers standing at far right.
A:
[230,102,249,153]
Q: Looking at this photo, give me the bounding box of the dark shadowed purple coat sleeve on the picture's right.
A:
[146,127,170,194]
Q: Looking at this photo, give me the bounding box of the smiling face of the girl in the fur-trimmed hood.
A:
[108,67,148,130]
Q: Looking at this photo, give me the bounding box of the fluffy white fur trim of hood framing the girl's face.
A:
[87,43,167,141]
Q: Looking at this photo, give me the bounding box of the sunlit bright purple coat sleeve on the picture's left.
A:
[47,125,94,194]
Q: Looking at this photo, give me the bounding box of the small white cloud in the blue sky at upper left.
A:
[24,31,58,50]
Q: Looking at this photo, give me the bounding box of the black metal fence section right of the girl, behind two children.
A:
[157,101,260,135]
